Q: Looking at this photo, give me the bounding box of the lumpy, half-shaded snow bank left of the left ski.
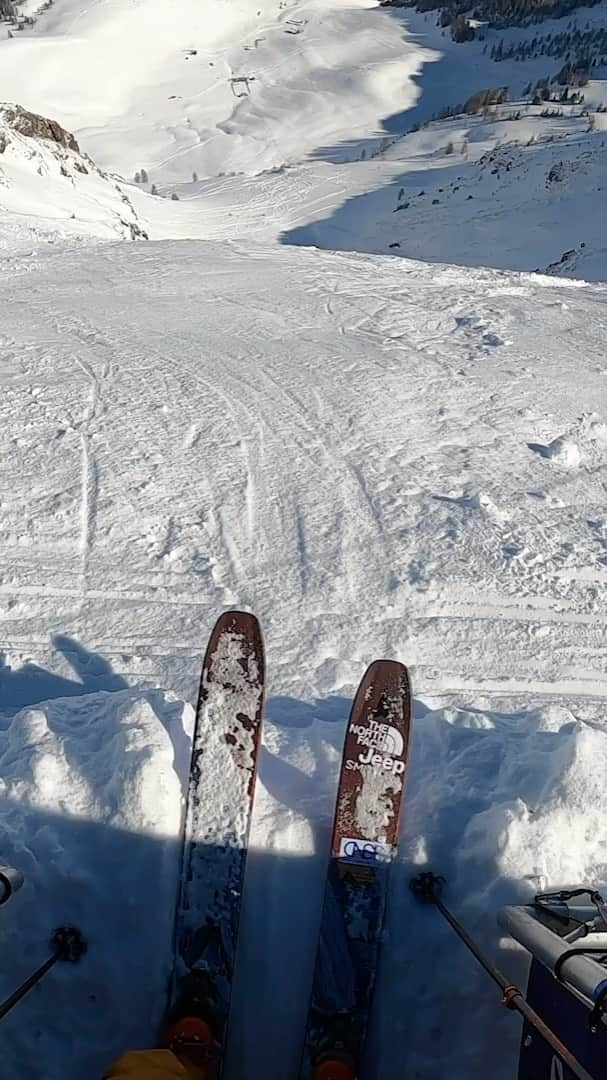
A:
[0,689,186,1080]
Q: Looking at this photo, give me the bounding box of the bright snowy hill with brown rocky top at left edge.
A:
[0,104,145,248]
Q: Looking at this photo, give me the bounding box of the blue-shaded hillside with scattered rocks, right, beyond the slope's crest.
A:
[283,104,607,281]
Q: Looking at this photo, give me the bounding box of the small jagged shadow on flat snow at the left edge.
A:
[0,634,127,717]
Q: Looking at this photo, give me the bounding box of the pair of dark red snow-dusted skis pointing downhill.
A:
[171,611,412,1080]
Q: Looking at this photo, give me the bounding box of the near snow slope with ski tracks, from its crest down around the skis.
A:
[0,242,607,1080]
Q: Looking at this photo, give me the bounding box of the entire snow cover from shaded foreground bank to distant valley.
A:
[0,0,607,1080]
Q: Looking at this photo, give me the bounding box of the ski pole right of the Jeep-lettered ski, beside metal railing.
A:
[409,870,595,1080]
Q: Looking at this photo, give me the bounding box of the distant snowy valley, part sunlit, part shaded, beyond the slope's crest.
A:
[0,0,607,280]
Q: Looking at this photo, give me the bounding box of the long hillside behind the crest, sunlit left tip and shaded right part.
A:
[127,103,607,281]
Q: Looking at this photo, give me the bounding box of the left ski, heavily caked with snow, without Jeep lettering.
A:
[171,611,265,1072]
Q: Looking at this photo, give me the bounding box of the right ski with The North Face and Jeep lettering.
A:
[300,660,412,1080]
